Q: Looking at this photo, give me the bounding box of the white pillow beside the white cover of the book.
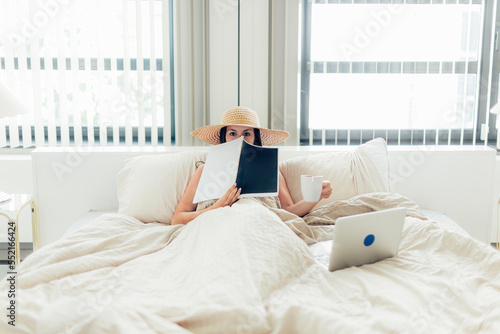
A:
[117,151,207,224]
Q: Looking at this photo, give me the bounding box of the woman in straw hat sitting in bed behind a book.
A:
[171,107,332,225]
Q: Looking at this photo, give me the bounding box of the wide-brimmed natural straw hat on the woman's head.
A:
[191,107,290,145]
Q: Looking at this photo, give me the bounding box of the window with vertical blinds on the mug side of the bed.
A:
[301,0,500,144]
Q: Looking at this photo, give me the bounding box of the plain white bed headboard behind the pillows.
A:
[32,146,496,246]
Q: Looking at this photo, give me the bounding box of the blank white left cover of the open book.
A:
[193,137,243,204]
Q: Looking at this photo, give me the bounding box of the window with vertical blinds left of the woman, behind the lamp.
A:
[0,0,173,147]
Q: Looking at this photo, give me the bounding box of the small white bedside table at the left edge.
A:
[0,194,39,267]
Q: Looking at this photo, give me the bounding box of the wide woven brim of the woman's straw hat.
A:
[191,124,290,145]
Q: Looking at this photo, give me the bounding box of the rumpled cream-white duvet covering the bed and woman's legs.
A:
[0,194,500,334]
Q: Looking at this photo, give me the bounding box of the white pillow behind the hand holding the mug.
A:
[280,138,390,207]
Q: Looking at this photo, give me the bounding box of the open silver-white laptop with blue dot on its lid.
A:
[316,208,406,271]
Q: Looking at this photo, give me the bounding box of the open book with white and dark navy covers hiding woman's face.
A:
[193,137,279,203]
